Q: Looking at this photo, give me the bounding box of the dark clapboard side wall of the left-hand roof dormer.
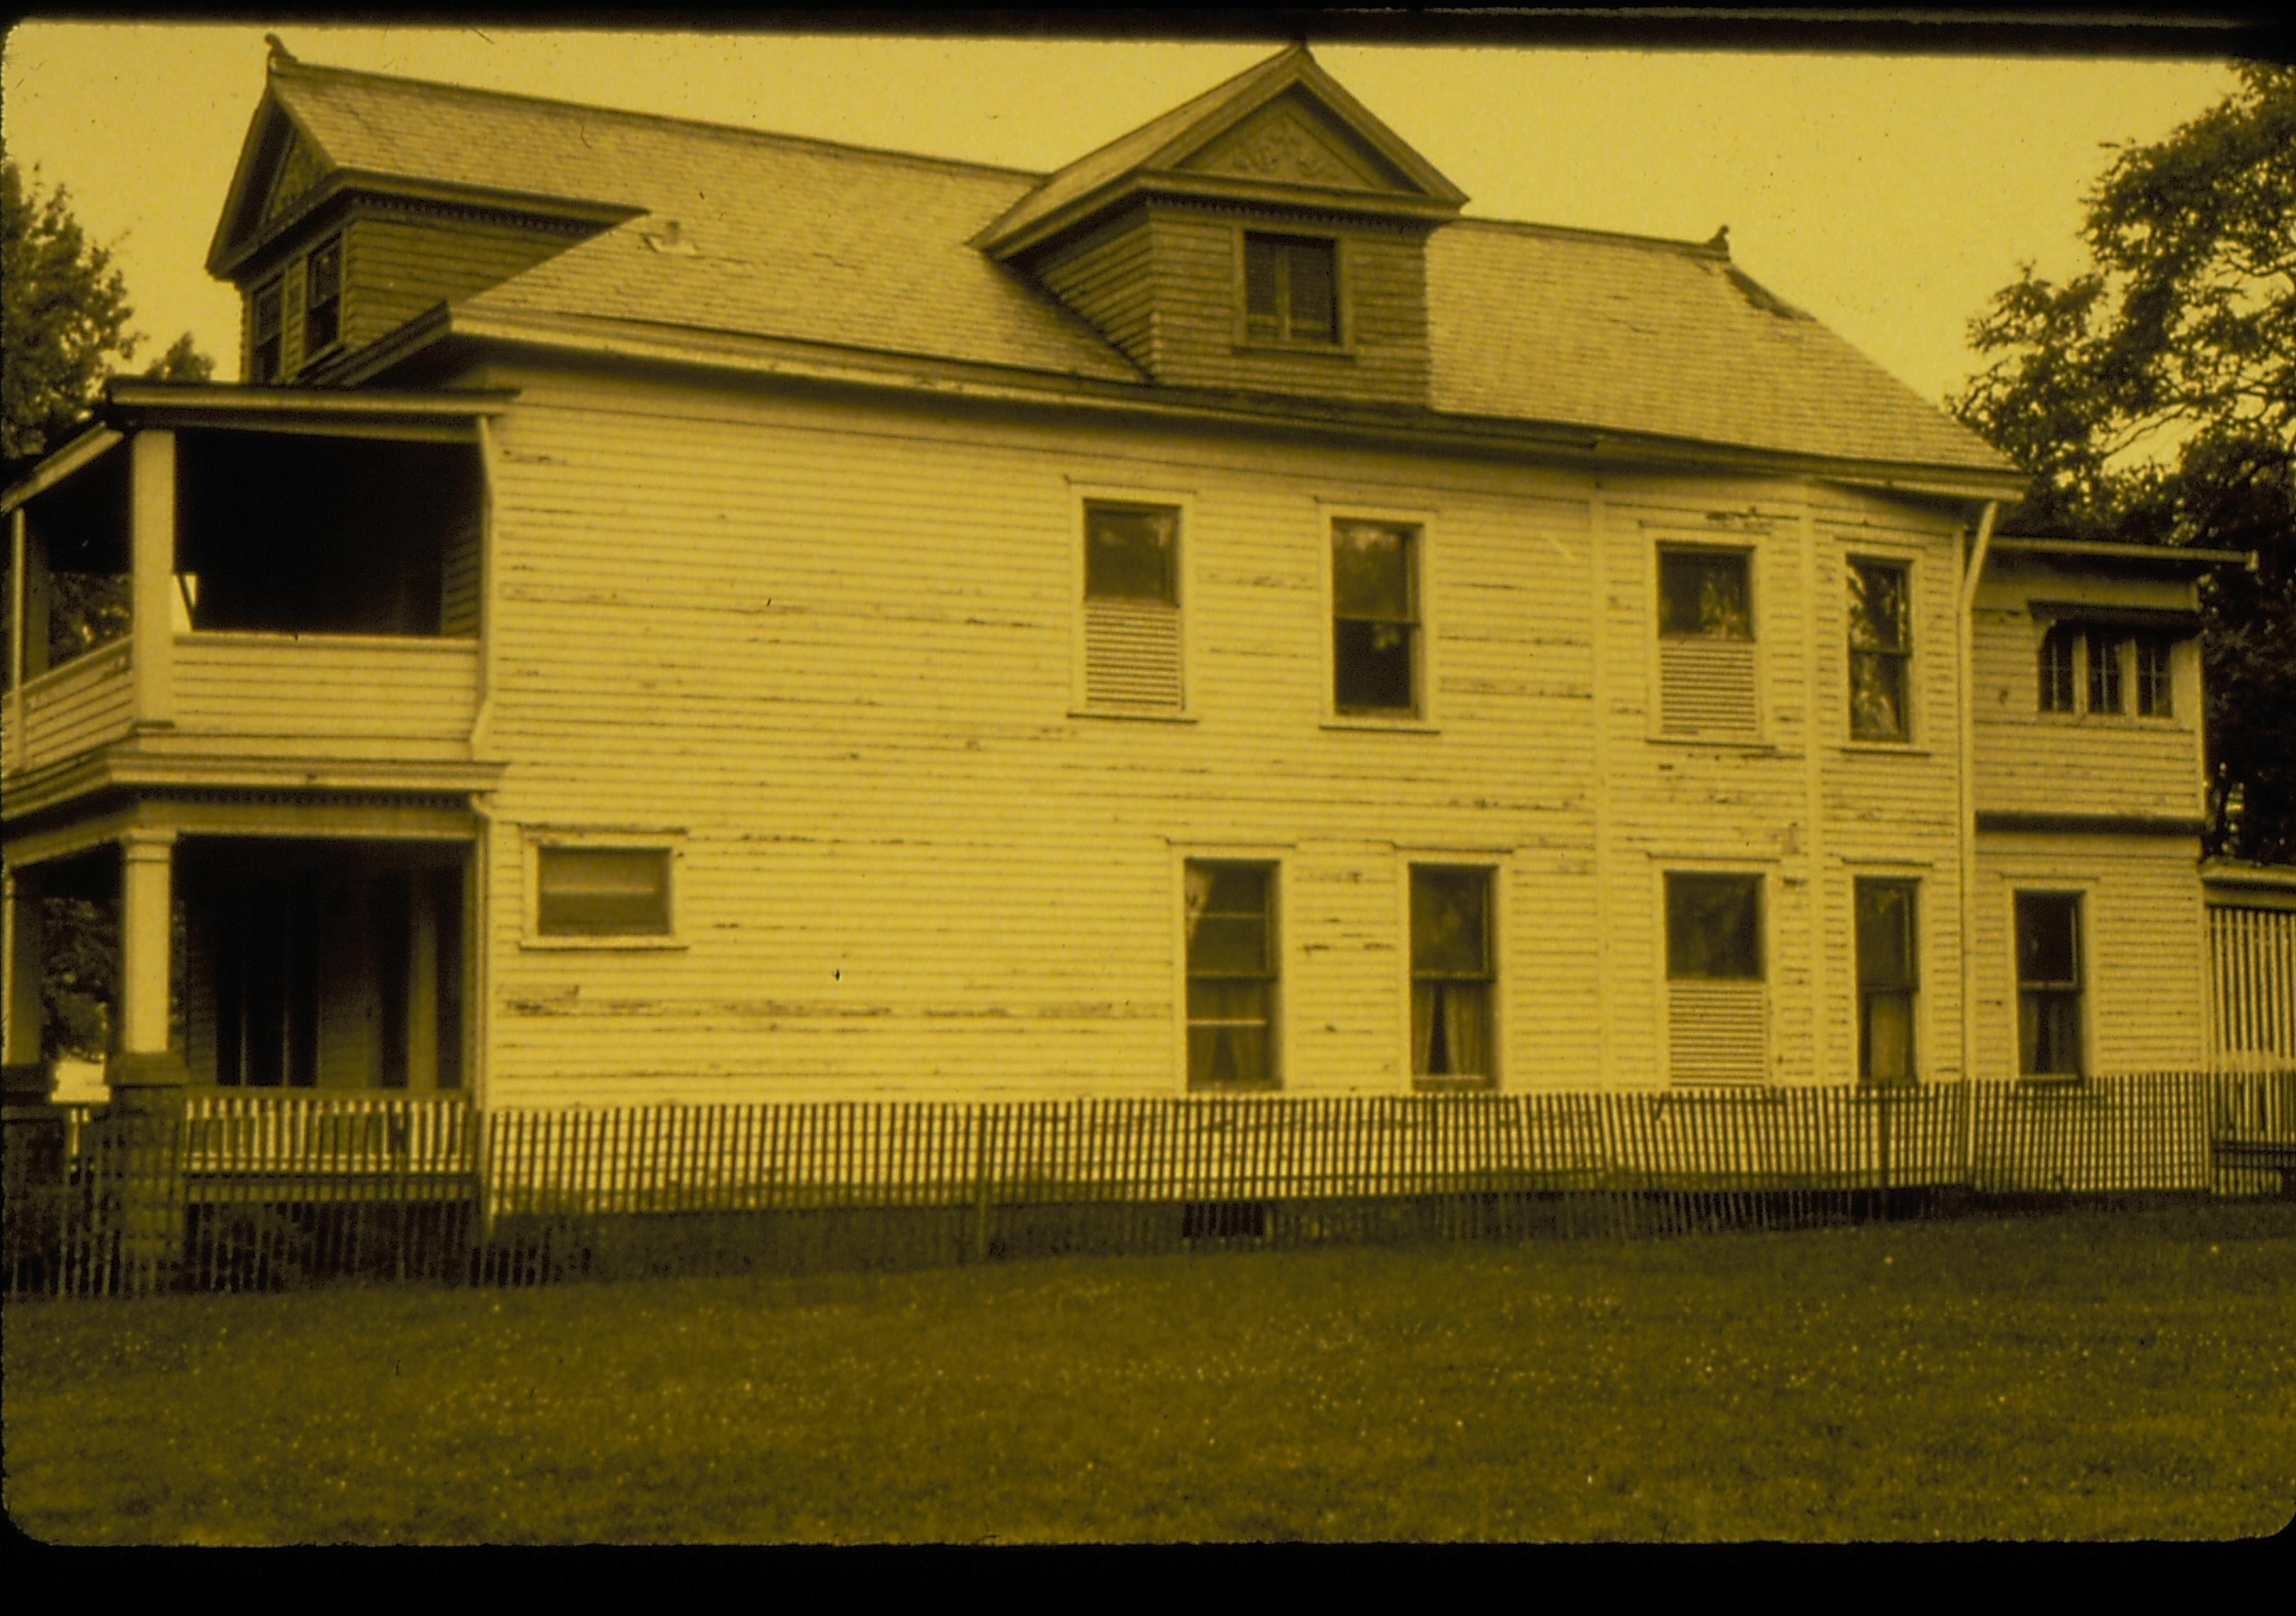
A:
[342,209,576,347]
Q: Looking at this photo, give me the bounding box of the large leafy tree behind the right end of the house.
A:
[1952,62,2296,863]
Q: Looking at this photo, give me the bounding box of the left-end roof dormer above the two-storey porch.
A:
[207,55,643,383]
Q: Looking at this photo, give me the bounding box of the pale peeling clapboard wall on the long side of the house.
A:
[447,353,1954,1104]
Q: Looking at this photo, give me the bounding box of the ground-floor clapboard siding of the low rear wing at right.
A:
[1972,831,2209,1077]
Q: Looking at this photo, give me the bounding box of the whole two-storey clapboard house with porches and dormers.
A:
[4,48,2292,1106]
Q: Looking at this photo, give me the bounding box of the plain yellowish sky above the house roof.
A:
[0,21,2234,402]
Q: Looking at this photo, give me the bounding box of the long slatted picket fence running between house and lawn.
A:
[4,1072,2296,1295]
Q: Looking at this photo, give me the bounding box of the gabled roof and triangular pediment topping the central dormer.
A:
[974,46,1467,259]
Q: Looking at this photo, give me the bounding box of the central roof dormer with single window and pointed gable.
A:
[974,46,1467,404]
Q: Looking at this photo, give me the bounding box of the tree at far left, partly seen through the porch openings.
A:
[0,161,213,1054]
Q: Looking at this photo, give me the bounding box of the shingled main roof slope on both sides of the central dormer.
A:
[242,52,2009,473]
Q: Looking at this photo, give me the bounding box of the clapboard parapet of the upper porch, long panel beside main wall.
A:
[163,634,478,762]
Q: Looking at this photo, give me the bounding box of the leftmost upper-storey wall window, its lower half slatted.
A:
[1084,500,1183,709]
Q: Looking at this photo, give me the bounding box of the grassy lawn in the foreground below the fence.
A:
[4,1205,2296,1542]
